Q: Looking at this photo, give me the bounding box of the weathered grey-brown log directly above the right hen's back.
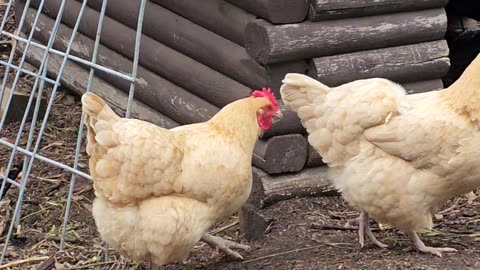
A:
[309,40,450,87]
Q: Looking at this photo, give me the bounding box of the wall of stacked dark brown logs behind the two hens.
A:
[16,0,449,238]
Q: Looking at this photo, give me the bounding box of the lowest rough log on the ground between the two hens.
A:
[248,166,338,208]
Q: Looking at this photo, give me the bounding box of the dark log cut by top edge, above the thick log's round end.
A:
[226,0,308,24]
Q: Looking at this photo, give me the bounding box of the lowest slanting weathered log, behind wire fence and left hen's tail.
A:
[17,41,178,128]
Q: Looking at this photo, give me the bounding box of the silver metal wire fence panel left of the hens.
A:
[0,0,146,265]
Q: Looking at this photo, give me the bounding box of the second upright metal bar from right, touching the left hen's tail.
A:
[60,0,108,251]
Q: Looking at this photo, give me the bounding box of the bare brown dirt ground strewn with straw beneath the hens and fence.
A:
[0,0,480,270]
